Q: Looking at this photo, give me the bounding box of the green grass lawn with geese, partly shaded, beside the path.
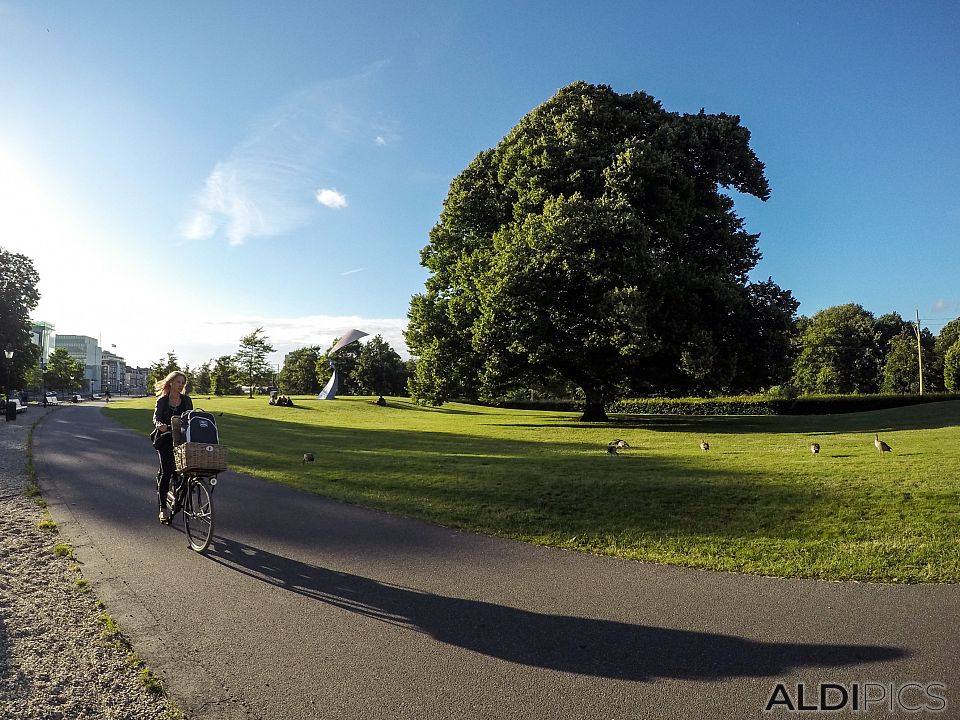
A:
[107,397,960,582]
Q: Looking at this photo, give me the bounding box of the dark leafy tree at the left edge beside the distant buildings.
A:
[0,247,40,391]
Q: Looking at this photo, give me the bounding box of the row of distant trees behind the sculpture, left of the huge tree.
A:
[148,328,411,397]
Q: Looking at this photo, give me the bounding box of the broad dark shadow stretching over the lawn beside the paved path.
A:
[221,417,831,539]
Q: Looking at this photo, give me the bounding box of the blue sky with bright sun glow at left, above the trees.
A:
[0,0,960,366]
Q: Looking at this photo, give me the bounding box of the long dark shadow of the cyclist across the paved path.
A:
[209,538,907,681]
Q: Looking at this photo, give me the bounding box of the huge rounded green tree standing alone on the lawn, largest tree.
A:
[406,82,793,420]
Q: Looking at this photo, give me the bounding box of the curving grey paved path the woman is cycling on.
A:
[34,405,960,720]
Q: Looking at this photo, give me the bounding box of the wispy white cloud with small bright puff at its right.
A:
[180,67,377,245]
